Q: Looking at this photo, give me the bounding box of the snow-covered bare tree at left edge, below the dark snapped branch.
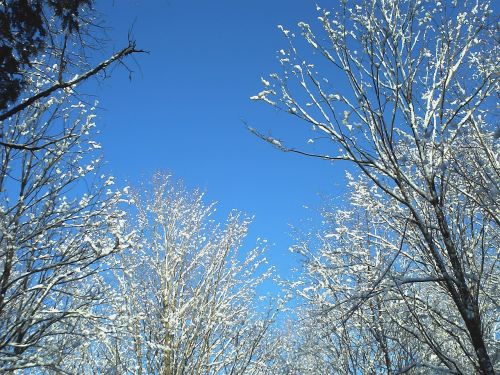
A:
[0,79,136,371]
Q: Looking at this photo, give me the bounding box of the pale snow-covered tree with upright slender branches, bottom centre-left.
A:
[72,175,276,375]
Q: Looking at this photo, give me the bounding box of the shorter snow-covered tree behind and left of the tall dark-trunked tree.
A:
[284,178,498,374]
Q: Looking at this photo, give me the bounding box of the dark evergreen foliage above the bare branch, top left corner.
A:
[0,0,139,115]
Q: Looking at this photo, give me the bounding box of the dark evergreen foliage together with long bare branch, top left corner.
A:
[0,0,142,123]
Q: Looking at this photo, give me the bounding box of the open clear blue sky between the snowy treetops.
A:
[92,0,346,280]
